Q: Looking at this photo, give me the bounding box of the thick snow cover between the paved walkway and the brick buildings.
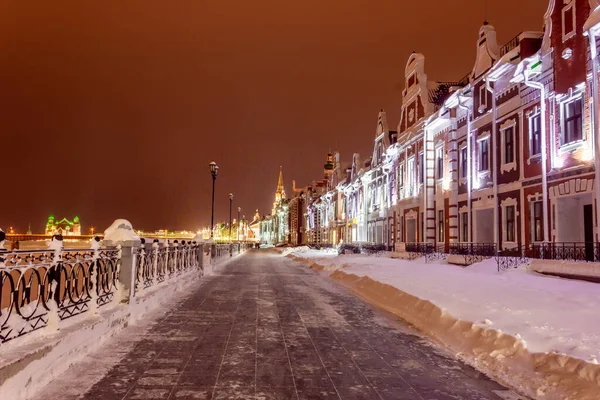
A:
[290,250,600,400]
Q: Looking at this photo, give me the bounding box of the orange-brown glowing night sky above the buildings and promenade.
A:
[0,0,548,232]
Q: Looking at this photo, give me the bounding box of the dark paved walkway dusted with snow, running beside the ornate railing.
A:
[38,250,519,400]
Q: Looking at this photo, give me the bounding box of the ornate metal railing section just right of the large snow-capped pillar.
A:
[136,239,202,292]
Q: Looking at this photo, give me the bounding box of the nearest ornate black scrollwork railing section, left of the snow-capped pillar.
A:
[0,248,121,343]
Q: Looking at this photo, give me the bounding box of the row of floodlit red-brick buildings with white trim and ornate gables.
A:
[278,0,600,255]
